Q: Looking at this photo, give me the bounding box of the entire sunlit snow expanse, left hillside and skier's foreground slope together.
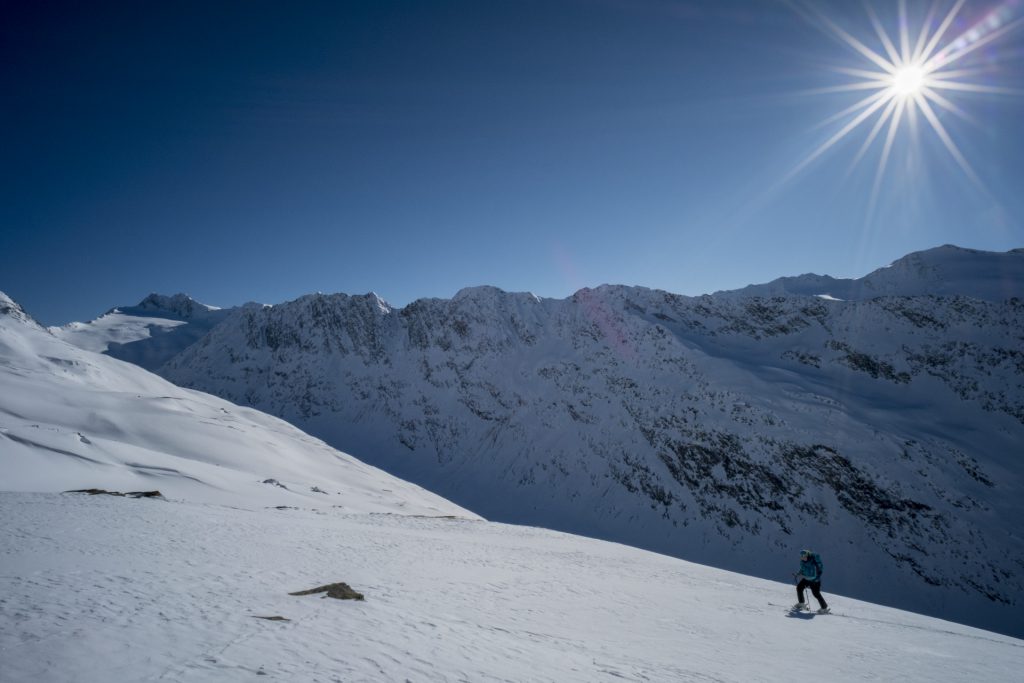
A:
[0,295,1024,682]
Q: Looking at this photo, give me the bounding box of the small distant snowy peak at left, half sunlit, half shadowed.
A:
[50,294,234,370]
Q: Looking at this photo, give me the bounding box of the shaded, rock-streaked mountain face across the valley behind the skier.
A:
[161,250,1024,635]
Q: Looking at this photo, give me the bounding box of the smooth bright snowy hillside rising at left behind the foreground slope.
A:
[0,293,476,518]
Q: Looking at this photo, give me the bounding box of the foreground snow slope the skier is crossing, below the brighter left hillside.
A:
[0,494,1024,683]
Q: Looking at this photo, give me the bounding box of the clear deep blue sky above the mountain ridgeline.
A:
[0,0,1024,325]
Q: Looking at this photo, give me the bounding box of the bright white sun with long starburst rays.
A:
[786,0,1024,204]
